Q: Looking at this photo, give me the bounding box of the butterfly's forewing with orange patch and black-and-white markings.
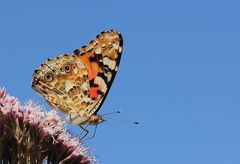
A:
[74,30,123,114]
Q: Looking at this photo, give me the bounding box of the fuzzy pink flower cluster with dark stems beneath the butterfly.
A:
[0,88,95,164]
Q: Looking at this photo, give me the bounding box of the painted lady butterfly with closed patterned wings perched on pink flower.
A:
[32,30,123,125]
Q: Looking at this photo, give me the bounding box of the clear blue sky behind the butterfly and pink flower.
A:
[0,0,240,164]
